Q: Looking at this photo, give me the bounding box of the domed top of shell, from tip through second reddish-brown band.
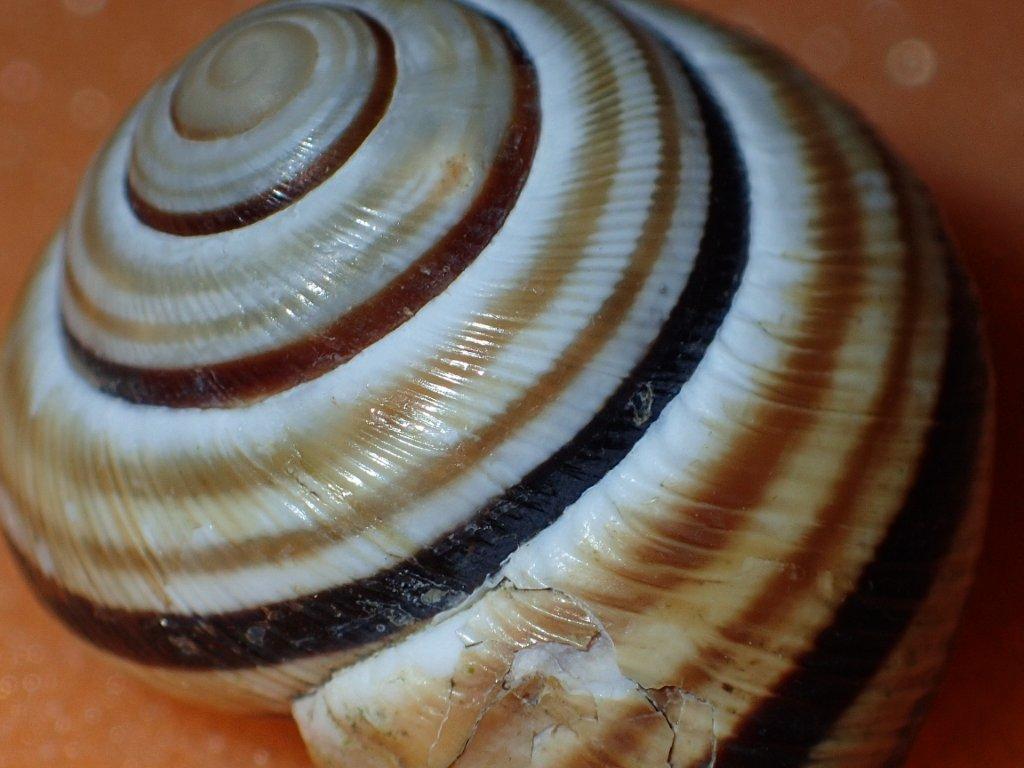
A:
[62,4,539,407]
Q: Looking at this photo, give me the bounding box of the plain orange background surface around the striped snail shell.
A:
[0,0,1024,768]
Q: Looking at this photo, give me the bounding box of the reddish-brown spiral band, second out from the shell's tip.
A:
[63,22,541,408]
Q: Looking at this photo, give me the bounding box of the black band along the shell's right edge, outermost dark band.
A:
[709,246,987,768]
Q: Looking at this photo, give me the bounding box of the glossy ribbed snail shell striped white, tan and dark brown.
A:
[0,0,989,768]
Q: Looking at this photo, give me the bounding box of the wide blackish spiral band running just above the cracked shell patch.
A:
[14,49,750,670]
